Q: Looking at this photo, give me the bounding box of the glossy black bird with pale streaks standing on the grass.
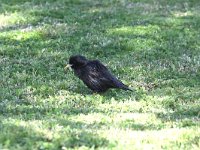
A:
[69,55,132,93]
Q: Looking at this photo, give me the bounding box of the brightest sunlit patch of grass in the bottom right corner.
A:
[103,128,199,150]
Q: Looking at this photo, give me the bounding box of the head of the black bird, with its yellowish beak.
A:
[66,55,88,69]
